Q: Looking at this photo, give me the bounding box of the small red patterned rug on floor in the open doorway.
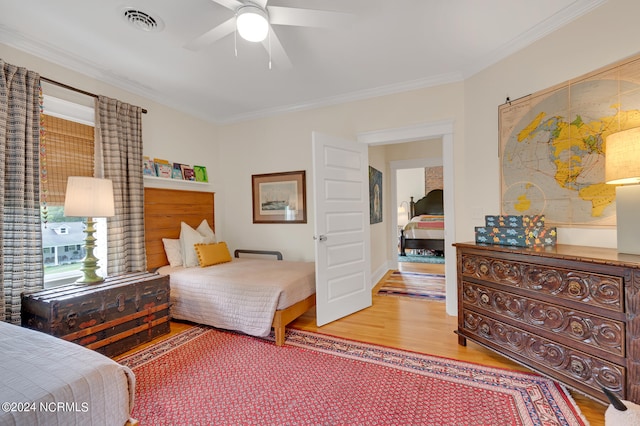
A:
[378,271,446,301]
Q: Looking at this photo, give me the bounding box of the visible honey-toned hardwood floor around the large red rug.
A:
[122,263,606,426]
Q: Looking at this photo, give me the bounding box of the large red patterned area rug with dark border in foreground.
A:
[119,326,587,426]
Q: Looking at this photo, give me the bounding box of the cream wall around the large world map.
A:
[456,0,640,247]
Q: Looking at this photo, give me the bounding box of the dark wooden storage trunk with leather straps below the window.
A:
[22,272,169,357]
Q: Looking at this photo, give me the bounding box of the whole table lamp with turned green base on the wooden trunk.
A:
[64,176,115,284]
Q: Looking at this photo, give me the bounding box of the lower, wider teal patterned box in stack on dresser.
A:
[475,226,558,247]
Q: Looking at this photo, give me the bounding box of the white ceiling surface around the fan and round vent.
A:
[0,0,606,123]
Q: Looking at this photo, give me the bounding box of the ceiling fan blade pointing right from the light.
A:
[267,6,353,28]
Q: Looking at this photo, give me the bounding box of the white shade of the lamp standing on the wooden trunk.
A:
[64,176,115,217]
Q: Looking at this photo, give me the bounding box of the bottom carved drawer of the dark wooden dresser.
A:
[459,309,627,399]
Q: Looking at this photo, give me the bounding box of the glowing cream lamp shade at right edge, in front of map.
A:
[605,127,640,184]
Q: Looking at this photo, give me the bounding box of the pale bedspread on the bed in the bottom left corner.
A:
[0,322,135,426]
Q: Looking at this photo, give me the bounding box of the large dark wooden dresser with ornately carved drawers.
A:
[455,243,640,403]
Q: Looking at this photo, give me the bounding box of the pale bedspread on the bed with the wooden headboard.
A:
[158,258,316,337]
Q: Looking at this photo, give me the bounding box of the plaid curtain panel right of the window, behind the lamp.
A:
[96,96,147,275]
